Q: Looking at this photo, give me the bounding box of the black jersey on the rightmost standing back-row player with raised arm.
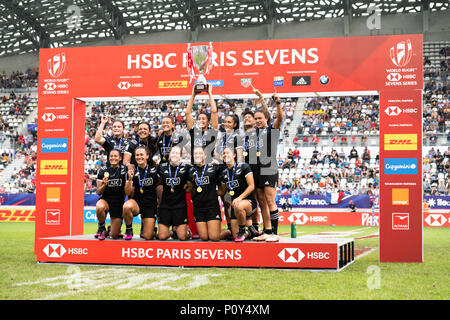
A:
[256,124,280,175]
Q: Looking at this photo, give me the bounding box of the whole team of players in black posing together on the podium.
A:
[95,85,283,242]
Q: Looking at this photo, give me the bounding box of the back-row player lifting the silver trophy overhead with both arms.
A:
[186,85,219,163]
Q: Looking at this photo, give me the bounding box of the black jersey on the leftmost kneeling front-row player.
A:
[97,165,127,203]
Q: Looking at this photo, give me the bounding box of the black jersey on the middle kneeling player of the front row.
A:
[158,162,191,209]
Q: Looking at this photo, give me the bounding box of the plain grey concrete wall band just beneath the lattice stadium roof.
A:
[0,10,450,73]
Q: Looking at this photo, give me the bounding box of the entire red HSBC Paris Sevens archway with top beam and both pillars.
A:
[35,34,423,265]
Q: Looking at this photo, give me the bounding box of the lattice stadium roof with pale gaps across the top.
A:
[0,0,450,57]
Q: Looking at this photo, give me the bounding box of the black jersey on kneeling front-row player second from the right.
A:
[189,164,221,208]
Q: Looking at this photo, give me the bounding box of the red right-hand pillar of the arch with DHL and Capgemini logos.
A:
[380,89,423,262]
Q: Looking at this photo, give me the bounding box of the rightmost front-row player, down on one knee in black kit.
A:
[218,147,256,242]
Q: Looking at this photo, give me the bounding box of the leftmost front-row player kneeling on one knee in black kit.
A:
[95,149,126,240]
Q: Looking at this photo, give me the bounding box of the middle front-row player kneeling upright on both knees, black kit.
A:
[158,146,192,240]
